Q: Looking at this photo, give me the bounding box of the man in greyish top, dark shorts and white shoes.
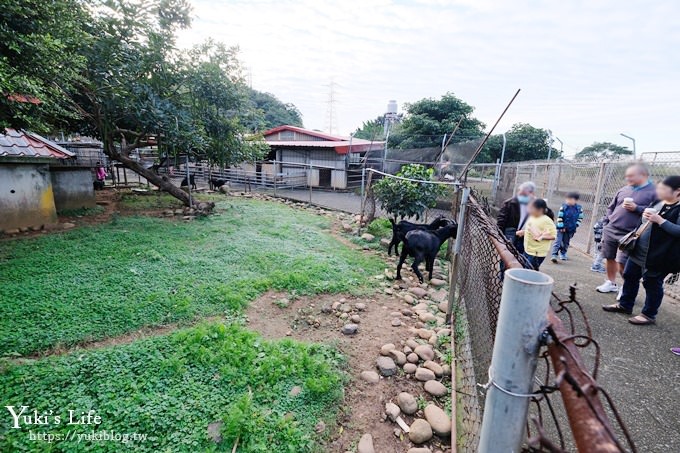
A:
[597,163,656,299]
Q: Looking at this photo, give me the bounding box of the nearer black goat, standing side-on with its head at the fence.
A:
[397,222,458,283]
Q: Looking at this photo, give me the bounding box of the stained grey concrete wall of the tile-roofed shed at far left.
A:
[0,163,57,230]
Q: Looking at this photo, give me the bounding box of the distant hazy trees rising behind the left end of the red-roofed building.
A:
[246,88,303,132]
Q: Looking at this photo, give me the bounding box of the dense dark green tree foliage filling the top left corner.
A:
[0,0,87,132]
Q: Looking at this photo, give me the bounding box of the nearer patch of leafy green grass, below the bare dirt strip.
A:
[0,323,345,453]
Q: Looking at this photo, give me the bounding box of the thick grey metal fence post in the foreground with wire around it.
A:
[478,269,554,453]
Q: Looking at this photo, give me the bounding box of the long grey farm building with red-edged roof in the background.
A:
[264,126,384,189]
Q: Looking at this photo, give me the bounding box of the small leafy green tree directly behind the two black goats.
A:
[373,164,444,221]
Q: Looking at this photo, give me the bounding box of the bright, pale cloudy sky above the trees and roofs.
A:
[180,0,680,155]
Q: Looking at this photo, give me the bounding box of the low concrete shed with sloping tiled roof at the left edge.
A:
[0,129,95,231]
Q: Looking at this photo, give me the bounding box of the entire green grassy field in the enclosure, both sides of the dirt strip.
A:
[0,200,383,453]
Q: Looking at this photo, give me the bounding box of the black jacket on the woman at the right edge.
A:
[646,203,680,274]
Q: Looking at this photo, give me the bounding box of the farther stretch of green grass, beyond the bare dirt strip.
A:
[0,200,383,355]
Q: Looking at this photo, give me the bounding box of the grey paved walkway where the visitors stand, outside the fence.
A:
[541,251,680,452]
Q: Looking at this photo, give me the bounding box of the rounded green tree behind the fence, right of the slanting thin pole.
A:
[477,123,562,163]
